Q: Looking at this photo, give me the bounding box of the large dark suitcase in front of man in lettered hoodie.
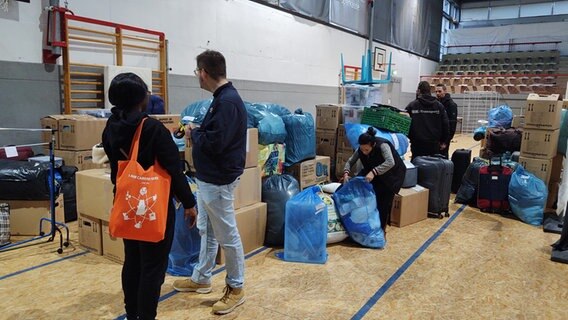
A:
[412,157,454,218]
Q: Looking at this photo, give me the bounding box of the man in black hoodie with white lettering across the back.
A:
[406,81,449,159]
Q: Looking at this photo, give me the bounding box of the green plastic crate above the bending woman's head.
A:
[361,107,410,135]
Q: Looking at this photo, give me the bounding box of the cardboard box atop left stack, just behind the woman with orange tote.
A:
[58,115,107,151]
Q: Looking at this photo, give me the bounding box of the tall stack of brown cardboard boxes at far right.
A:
[519,93,562,206]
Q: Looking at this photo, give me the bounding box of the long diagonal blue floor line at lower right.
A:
[351,204,466,320]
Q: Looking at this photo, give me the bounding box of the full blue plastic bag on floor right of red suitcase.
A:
[509,165,548,226]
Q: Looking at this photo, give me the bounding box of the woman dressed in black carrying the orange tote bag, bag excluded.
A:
[102,73,197,319]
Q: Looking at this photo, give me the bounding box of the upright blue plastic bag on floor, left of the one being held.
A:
[284,187,328,264]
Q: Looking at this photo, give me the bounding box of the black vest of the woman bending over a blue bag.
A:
[357,137,406,193]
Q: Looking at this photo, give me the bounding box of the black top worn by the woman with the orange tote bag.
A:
[102,108,195,210]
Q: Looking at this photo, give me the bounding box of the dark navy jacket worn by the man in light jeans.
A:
[191,82,247,185]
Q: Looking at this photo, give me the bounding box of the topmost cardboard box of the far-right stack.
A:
[524,93,562,130]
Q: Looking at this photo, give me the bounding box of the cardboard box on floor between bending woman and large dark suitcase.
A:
[390,184,429,227]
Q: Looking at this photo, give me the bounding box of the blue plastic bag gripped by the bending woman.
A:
[333,177,386,249]
